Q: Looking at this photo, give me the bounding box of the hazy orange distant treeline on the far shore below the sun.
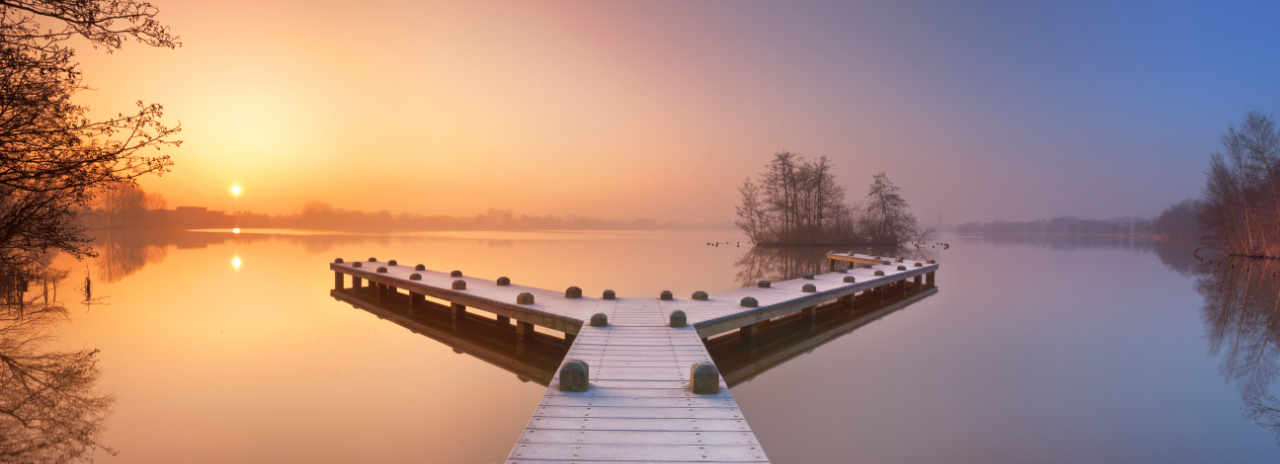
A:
[79,185,696,232]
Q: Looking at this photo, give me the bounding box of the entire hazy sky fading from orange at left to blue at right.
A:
[74,0,1280,223]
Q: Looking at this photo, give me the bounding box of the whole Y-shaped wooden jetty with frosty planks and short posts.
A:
[329,253,938,463]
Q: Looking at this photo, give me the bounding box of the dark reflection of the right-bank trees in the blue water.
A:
[1196,258,1280,440]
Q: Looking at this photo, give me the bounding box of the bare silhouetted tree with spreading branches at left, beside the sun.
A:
[0,0,179,267]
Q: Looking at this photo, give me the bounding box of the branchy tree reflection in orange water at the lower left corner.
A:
[0,267,111,463]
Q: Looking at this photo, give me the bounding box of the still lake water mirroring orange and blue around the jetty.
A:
[32,226,1280,463]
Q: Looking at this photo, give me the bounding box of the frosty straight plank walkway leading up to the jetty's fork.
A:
[507,299,768,463]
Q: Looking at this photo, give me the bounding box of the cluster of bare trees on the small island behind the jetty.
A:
[735,151,919,246]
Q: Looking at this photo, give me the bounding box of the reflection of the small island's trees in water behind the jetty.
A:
[733,246,931,287]
